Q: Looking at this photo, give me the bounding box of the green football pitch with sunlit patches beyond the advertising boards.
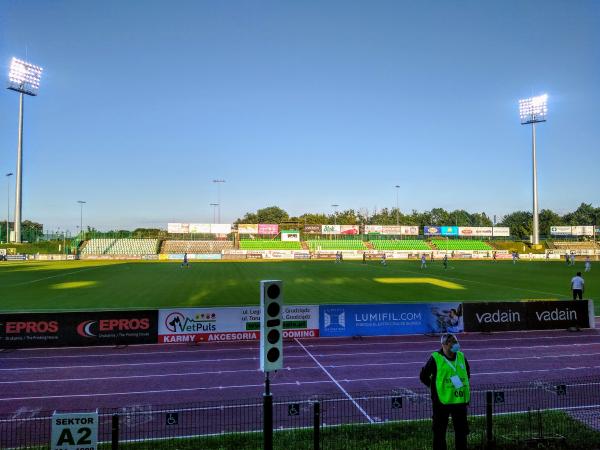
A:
[0,261,600,312]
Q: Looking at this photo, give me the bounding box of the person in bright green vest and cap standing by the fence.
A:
[419,333,471,450]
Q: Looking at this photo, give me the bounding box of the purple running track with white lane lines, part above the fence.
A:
[0,330,600,415]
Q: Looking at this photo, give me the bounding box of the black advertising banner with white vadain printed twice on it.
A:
[463,300,595,331]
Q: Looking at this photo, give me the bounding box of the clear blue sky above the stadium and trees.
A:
[0,0,600,230]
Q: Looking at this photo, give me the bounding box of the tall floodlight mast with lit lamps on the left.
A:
[7,58,44,243]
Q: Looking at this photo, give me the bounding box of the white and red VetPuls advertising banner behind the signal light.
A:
[158,305,319,343]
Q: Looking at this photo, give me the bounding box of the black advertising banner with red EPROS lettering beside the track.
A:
[0,310,158,348]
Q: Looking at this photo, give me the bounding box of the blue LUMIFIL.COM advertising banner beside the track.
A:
[319,303,464,337]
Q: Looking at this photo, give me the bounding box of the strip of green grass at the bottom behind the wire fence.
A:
[104,411,600,450]
